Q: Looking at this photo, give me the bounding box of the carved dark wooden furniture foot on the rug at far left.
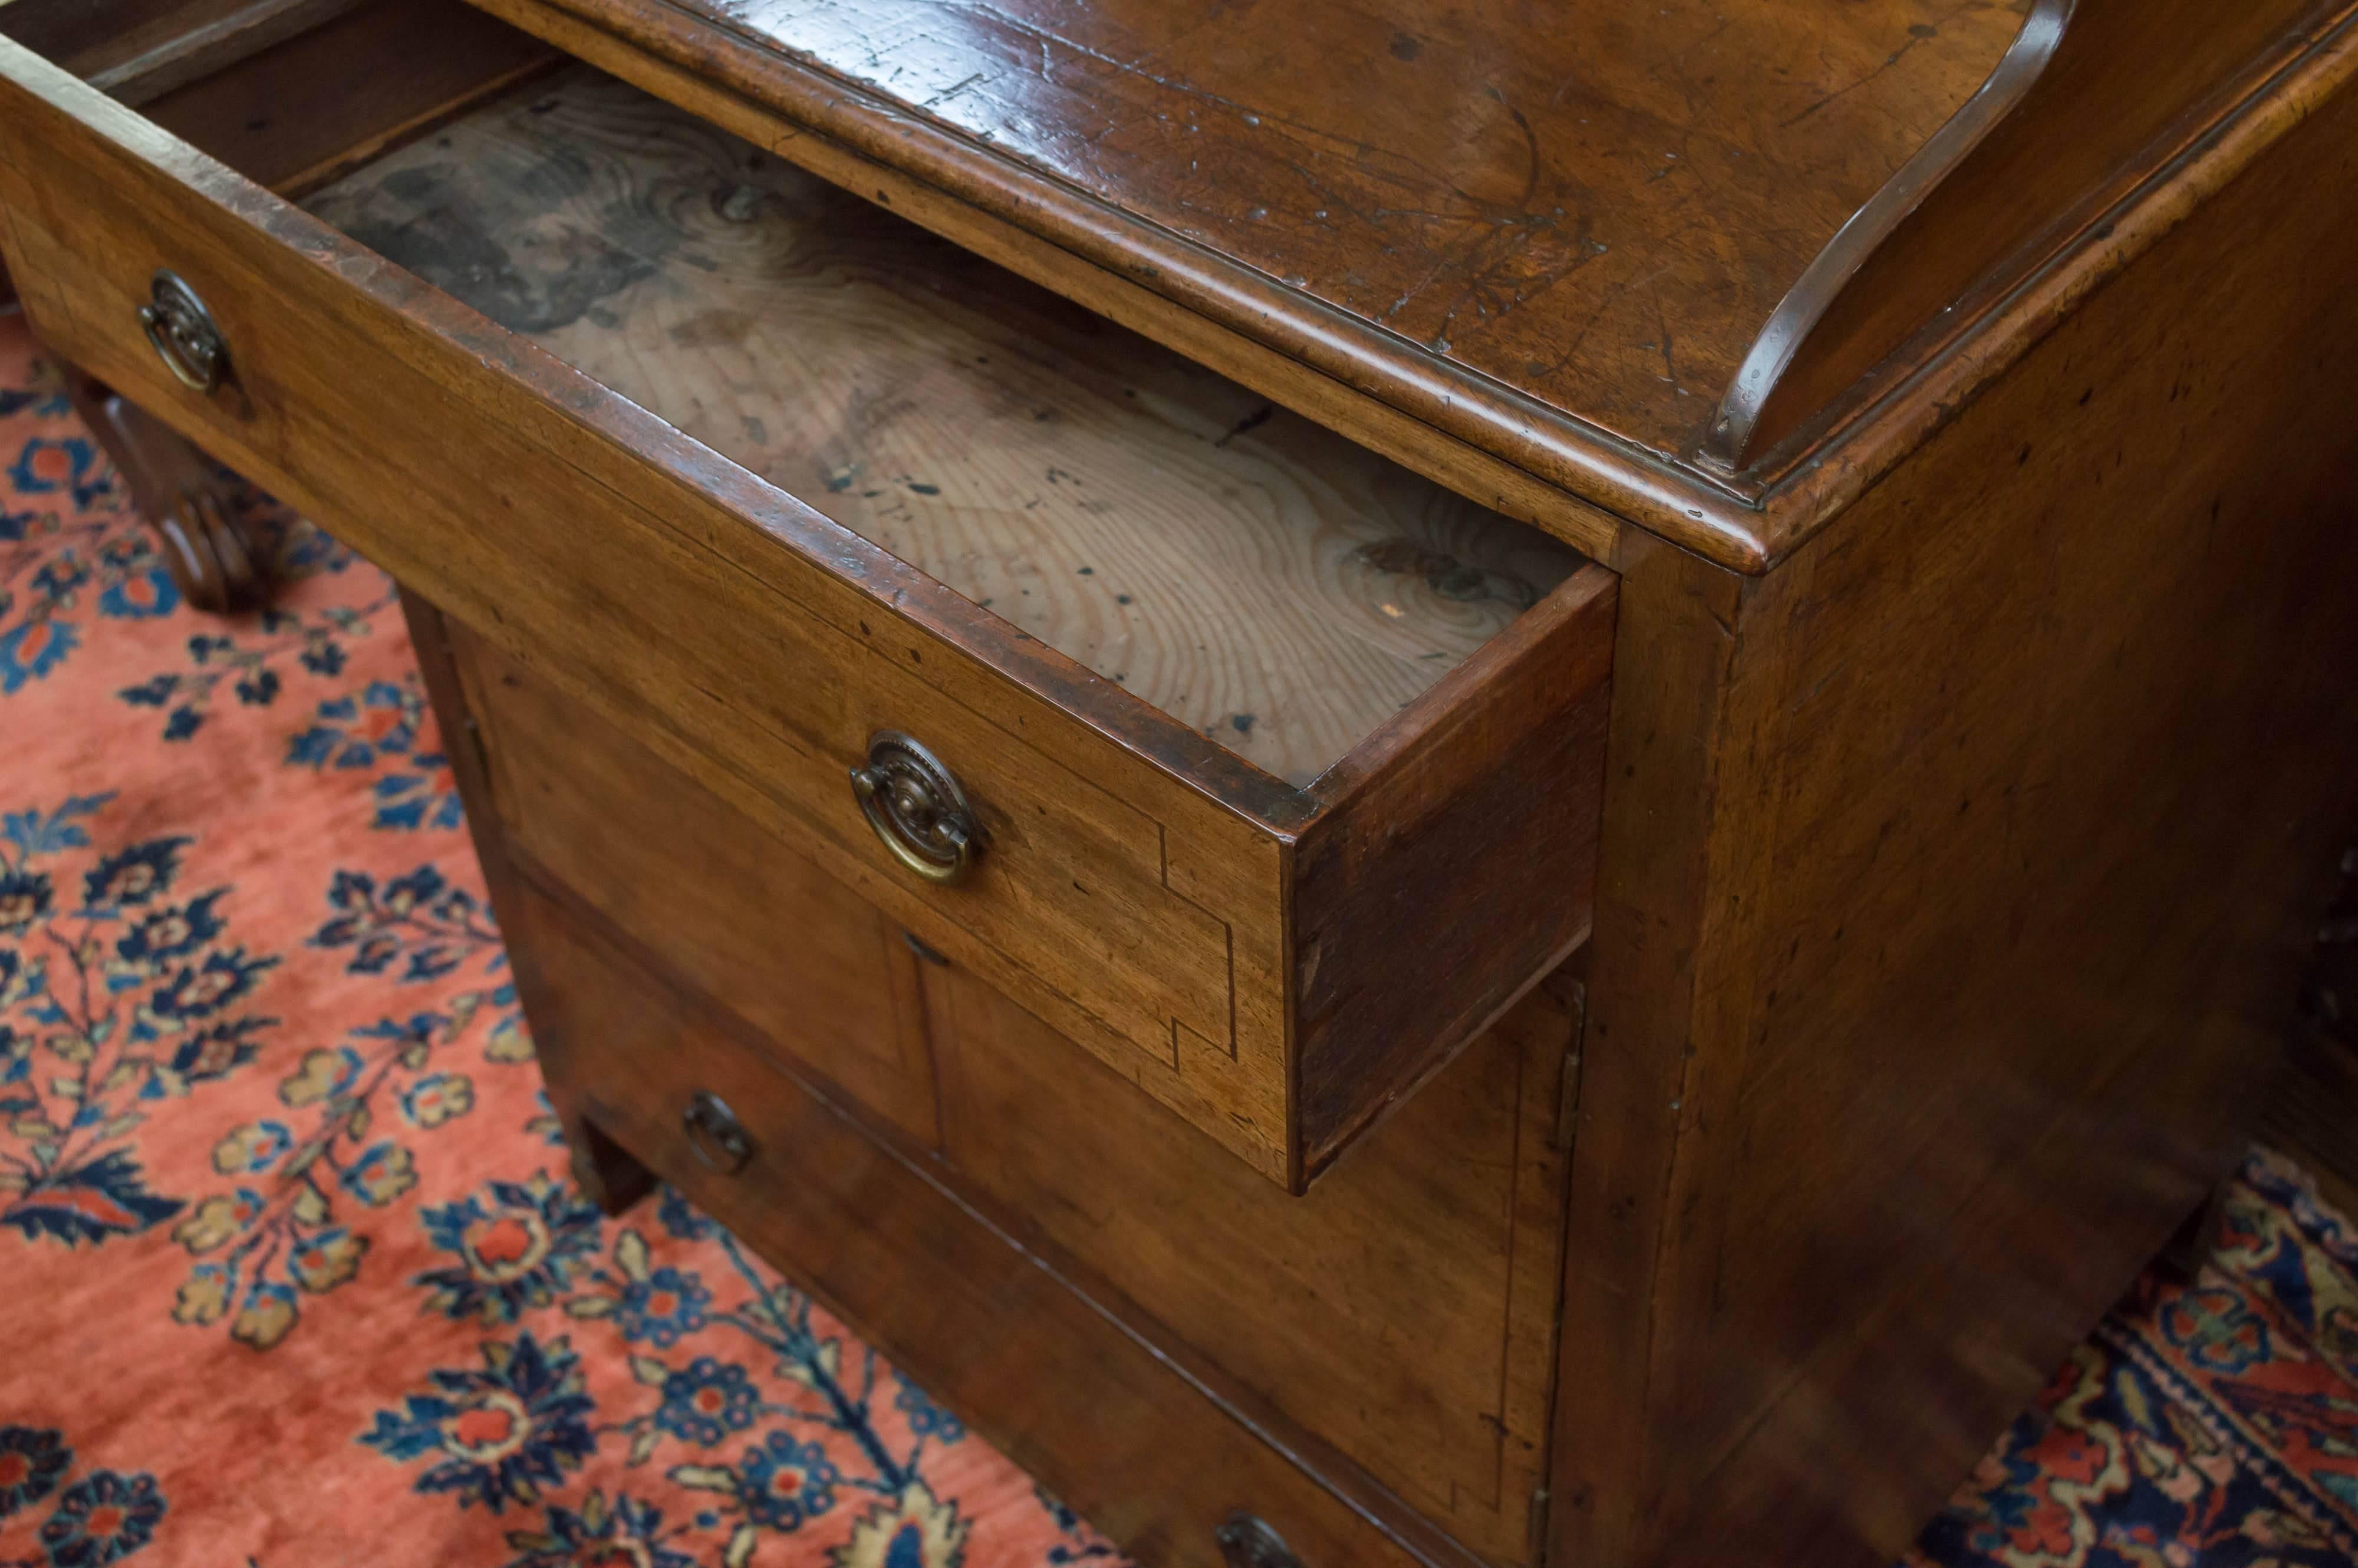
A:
[61,365,266,615]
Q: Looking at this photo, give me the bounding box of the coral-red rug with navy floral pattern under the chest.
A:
[0,318,2358,1568]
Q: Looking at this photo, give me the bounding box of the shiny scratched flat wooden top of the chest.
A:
[580,0,2023,472]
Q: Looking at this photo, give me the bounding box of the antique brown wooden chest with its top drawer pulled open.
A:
[0,0,2358,1568]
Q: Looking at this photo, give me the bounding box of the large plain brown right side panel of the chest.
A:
[1632,67,2358,1566]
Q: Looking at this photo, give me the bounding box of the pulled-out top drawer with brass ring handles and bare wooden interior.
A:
[0,0,1615,1191]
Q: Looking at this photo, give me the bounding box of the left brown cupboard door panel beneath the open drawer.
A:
[441,618,938,1148]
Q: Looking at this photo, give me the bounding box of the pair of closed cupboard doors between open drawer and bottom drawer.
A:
[427,622,1578,1559]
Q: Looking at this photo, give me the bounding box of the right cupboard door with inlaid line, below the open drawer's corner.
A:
[927,953,1573,1561]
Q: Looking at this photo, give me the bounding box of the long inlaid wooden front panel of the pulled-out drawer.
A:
[0,42,1297,1179]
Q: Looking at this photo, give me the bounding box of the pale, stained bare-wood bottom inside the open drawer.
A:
[307,68,1580,785]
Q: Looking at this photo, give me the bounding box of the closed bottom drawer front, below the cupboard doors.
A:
[502,887,1467,1568]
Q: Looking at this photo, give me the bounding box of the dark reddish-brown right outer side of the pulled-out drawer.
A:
[1295,566,1620,1181]
